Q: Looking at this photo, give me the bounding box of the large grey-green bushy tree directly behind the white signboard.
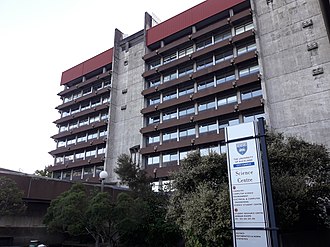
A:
[168,133,330,246]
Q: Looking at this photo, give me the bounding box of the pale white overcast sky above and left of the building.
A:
[0,0,203,173]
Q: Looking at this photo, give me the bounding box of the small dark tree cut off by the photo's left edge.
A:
[0,177,26,217]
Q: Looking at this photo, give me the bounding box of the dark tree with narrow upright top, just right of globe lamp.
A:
[114,154,180,247]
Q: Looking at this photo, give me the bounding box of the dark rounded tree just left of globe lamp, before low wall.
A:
[44,184,114,246]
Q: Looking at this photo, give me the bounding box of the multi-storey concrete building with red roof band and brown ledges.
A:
[50,0,330,185]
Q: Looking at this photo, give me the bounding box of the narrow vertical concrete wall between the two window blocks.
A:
[106,30,145,182]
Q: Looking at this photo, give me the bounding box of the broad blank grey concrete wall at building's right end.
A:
[251,0,330,147]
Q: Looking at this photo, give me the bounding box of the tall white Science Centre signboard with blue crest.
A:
[226,123,269,247]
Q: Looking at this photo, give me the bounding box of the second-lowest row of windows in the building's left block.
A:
[55,145,105,164]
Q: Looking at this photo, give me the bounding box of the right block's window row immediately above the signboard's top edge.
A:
[146,113,264,145]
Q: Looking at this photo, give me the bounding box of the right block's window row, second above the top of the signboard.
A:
[147,88,262,125]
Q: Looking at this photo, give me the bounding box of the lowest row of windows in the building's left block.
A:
[52,165,104,180]
